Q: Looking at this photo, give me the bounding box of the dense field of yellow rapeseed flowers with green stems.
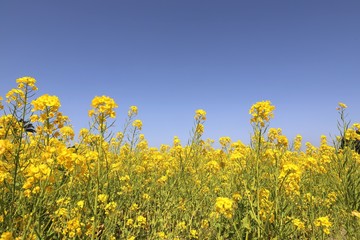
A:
[0,77,360,240]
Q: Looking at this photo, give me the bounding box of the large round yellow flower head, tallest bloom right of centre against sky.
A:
[249,100,275,127]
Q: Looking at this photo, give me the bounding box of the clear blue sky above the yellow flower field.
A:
[0,0,360,146]
